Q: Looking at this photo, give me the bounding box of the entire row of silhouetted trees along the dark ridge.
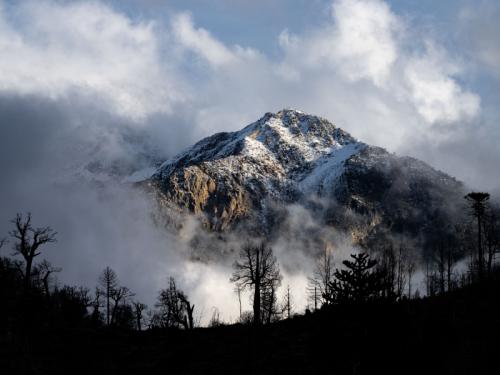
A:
[0,192,500,333]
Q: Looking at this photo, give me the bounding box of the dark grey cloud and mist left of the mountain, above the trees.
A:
[0,94,183,304]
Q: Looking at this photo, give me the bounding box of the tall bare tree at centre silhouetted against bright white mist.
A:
[230,242,281,325]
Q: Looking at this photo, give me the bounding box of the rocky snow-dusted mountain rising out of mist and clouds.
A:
[141,110,463,253]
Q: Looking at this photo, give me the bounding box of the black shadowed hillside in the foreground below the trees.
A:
[0,274,500,374]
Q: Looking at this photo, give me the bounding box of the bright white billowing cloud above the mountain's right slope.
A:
[279,0,480,127]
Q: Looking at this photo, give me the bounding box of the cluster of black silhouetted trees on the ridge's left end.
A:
[0,213,199,334]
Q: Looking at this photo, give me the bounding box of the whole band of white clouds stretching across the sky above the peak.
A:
[0,0,480,140]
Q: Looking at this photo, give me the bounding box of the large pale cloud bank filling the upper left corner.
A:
[0,1,183,119]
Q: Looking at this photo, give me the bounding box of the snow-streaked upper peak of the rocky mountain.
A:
[148,109,366,196]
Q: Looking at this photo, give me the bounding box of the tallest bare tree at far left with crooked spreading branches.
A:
[9,213,57,288]
